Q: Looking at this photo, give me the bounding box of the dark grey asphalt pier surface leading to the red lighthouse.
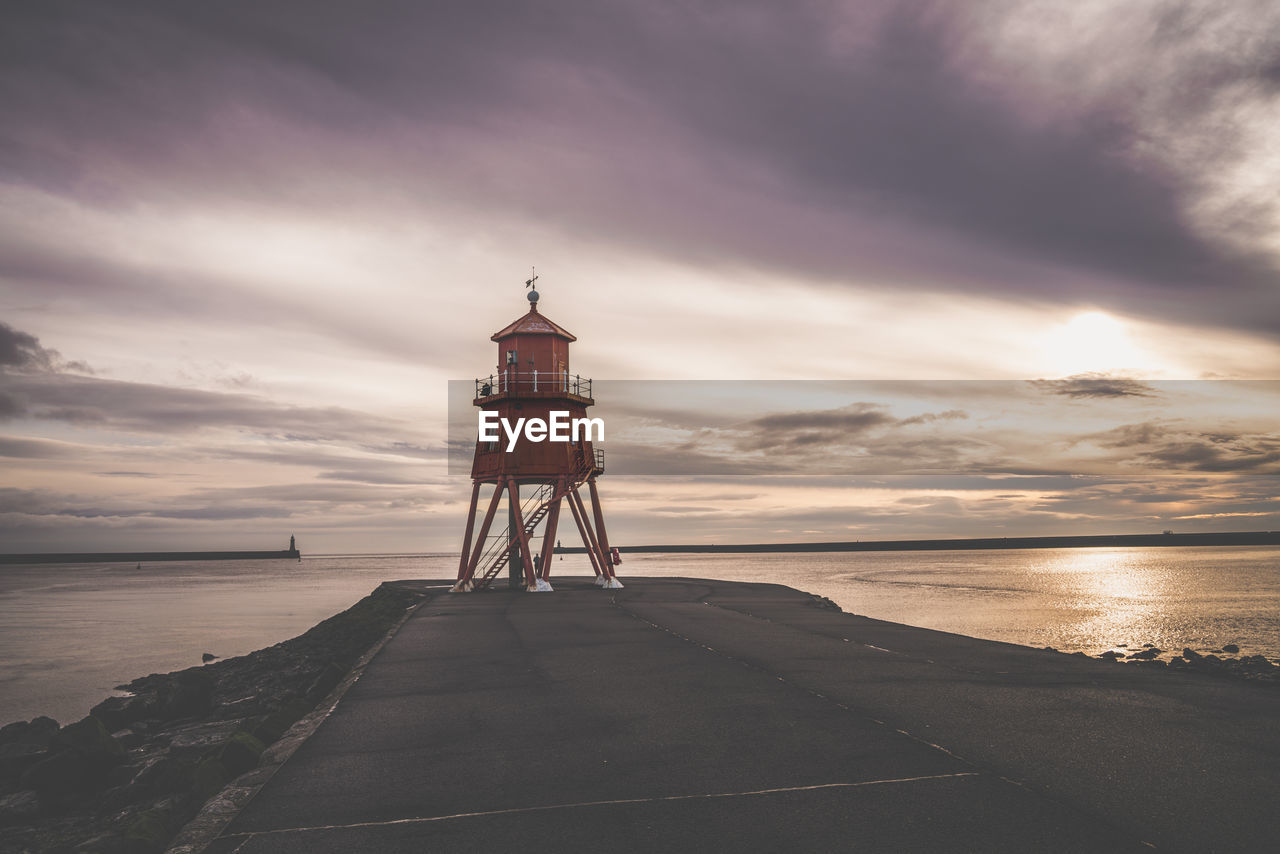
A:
[207,579,1280,854]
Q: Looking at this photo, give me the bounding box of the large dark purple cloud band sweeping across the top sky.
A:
[0,0,1280,332]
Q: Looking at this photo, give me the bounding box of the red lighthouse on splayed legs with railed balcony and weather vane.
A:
[453,277,622,592]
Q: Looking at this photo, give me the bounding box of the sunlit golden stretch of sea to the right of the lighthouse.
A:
[628,547,1280,658]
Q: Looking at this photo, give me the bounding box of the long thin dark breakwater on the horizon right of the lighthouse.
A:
[573,531,1280,554]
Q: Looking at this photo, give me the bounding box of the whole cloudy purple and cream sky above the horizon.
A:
[0,0,1280,553]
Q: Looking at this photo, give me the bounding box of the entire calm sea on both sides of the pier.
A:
[0,547,1280,723]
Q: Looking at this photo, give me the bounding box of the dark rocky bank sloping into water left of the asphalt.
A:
[0,584,424,854]
